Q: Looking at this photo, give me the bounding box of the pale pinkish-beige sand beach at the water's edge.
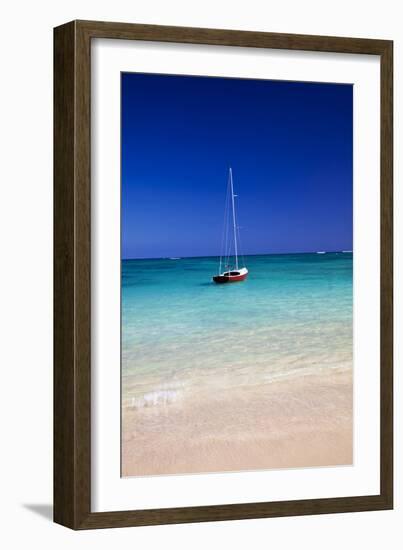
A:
[122,369,353,476]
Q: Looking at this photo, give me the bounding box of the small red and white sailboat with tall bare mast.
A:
[213,168,248,283]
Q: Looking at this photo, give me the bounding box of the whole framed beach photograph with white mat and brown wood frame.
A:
[54,21,393,529]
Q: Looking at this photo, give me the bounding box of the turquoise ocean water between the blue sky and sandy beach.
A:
[122,252,353,408]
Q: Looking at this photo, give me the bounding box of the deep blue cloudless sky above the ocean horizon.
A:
[122,73,353,258]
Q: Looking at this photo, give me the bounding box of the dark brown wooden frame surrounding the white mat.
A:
[54,21,393,529]
